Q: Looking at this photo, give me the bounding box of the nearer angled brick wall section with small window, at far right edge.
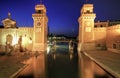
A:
[106,24,120,53]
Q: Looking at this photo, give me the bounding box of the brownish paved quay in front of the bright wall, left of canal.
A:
[0,52,33,78]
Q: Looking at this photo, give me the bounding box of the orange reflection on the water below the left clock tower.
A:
[15,53,46,78]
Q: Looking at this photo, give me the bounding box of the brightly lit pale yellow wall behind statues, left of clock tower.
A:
[0,27,34,52]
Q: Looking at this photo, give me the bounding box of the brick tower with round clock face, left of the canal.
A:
[32,4,48,51]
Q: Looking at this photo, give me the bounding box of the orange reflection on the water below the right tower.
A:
[79,53,115,78]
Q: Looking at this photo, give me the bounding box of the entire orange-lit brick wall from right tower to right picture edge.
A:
[94,24,120,53]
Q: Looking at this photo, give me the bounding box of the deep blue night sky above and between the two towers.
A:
[0,0,120,36]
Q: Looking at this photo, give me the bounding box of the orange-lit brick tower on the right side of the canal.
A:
[78,4,96,51]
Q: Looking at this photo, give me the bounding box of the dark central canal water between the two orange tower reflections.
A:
[47,44,78,78]
